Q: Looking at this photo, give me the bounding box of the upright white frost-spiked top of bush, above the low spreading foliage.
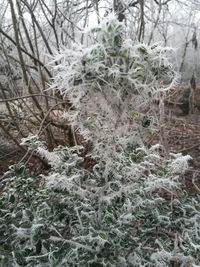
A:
[52,15,176,157]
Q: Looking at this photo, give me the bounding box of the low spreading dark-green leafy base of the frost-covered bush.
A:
[0,137,200,267]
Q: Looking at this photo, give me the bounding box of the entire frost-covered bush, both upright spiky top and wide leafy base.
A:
[0,16,200,267]
